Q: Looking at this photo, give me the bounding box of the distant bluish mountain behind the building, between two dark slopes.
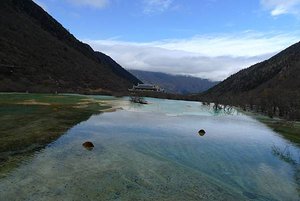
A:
[129,70,218,94]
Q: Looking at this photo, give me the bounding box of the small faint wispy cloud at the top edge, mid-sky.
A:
[143,0,173,14]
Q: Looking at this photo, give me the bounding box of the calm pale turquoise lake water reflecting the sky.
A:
[0,96,300,201]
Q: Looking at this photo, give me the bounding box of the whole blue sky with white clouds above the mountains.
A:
[34,0,300,81]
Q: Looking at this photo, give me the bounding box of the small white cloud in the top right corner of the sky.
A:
[260,0,300,16]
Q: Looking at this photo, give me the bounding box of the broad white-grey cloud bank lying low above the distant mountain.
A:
[85,32,298,80]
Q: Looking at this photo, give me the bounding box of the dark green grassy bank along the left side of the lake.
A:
[0,93,110,177]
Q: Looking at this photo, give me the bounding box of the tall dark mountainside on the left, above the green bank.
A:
[0,0,140,93]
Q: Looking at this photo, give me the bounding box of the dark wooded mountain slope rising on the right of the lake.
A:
[200,42,300,119]
